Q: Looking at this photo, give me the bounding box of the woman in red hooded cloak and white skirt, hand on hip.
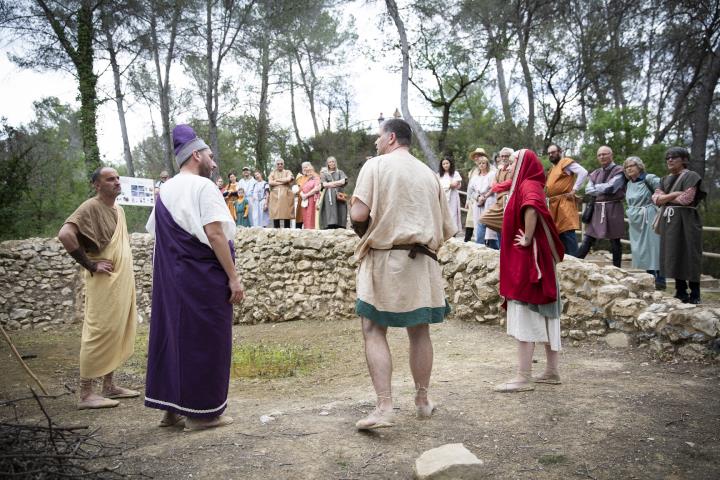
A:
[495,150,565,392]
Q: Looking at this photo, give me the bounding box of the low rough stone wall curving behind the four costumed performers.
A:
[0,228,720,359]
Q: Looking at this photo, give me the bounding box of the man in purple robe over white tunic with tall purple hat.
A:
[145,125,245,430]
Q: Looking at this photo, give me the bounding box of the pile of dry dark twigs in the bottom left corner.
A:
[0,389,145,479]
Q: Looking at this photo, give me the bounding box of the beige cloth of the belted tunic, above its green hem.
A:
[353,149,457,313]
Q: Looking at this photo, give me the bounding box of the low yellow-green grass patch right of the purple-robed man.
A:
[232,343,322,378]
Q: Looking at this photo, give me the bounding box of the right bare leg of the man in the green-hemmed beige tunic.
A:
[407,324,435,418]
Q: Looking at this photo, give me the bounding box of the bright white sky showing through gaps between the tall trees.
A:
[0,0,430,169]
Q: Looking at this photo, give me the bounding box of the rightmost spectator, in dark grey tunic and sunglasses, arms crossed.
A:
[652,147,707,304]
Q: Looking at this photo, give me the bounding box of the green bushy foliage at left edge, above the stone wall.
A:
[0,97,90,240]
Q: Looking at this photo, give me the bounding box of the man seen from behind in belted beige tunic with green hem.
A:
[350,119,457,430]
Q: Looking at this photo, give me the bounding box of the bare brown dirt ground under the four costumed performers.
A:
[0,321,720,480]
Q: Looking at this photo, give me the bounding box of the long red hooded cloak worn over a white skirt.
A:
[500,150,565,305]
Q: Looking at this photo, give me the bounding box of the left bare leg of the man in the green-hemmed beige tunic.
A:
[355,318,394,430]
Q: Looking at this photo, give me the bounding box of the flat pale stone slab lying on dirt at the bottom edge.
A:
[415,443,483,480]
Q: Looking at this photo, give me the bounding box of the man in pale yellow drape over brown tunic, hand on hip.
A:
[58,167,139,410]
